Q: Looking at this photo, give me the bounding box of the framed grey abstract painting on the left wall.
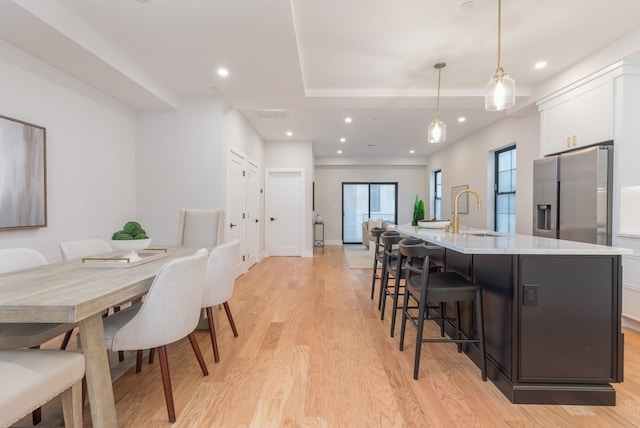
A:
[0,115,47,230]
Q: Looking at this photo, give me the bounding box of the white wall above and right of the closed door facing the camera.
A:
[264,141,313,257]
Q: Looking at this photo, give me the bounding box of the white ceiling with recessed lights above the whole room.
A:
[0,0,640,157]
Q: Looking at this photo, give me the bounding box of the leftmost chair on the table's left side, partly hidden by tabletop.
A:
[0,248,75,425]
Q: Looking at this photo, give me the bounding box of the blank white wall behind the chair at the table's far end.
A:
[136,96,227,245]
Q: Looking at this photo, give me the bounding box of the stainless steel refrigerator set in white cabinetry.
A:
[533,143,613,245]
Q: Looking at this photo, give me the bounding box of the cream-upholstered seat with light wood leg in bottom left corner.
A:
[0,349,85,428]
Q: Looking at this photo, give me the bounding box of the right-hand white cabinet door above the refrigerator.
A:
[574,81,613,147]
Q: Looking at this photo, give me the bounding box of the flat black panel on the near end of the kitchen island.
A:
[516,256,618,383]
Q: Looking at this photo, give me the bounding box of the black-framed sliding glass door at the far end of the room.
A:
[342,183,398,244]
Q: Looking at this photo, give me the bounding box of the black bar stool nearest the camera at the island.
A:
[400,237,487,381]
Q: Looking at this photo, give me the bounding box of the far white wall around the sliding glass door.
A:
[315,165,429,245]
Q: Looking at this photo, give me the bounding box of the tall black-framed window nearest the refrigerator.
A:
[495,146,516,233]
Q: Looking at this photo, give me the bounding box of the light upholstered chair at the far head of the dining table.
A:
[178,208,225,248]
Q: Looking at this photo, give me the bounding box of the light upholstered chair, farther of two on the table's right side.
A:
[202,239,240,363]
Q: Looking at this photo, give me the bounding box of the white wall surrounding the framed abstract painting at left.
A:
[0,40,136,262]
